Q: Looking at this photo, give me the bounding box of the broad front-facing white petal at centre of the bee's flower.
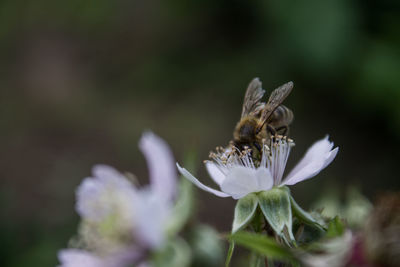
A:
[221,166,273,199]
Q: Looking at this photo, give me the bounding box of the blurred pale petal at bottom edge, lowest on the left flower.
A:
[58,249,107,267]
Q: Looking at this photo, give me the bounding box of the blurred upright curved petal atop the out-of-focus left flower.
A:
[139,132,176,199]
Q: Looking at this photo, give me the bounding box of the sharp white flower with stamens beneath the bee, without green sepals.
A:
[177,137,338,199]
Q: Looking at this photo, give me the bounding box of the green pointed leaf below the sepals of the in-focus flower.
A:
[230,231,295,261]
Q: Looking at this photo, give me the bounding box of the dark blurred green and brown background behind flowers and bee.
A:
[0,0,400,266]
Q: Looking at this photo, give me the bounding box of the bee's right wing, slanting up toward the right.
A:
[257,82,293,132]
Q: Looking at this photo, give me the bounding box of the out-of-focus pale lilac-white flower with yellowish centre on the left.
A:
[59,133,177,267]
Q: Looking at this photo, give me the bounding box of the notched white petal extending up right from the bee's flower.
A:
[282,136,339,185]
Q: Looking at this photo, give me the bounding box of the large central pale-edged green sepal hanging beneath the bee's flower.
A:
[258,187,295,245]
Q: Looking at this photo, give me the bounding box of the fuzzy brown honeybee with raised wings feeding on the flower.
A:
[233,78,294,151]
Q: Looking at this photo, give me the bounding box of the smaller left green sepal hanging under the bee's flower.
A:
[232,194,258,233]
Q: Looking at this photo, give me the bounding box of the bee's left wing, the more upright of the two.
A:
[242,78,265,118]
